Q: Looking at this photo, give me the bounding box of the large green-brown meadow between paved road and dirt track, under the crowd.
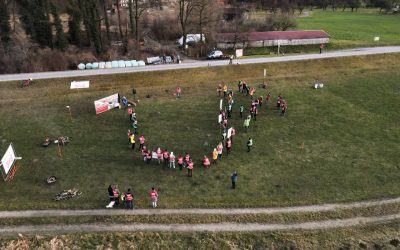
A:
[0,55,400,209]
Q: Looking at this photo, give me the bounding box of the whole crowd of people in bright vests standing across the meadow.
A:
[109,81,287,208]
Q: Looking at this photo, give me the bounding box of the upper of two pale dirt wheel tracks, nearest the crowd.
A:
[0,197,400,218]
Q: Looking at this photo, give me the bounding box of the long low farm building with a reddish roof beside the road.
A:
[215,30,329,49]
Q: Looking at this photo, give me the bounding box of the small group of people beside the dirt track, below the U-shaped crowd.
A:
[107,185,158,209]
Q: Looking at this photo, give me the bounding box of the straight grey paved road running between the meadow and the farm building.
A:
[0,46,400,82]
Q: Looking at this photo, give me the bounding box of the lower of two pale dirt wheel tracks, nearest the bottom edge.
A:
[0,214,400,235]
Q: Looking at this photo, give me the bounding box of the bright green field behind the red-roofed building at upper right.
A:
[296,10,400,49]
